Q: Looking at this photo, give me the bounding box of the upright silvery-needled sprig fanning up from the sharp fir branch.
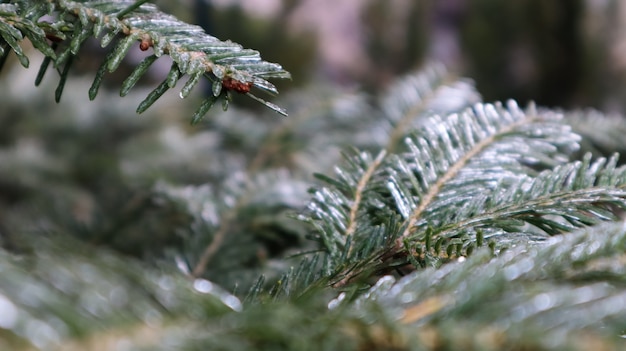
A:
[390,103,579,238]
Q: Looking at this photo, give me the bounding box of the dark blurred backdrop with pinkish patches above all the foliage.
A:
[168,0,626,111]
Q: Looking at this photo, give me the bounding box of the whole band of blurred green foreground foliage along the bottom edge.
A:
[0,223,626,350]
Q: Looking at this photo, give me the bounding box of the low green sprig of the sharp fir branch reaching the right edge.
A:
[433,154,626,239]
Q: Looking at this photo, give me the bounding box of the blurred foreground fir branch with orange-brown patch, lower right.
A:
[356,222,626,338]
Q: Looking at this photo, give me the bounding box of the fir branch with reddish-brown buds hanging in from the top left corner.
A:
[0,0,290,123]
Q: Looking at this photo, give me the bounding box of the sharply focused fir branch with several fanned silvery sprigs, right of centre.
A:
[310,95,626,287]
